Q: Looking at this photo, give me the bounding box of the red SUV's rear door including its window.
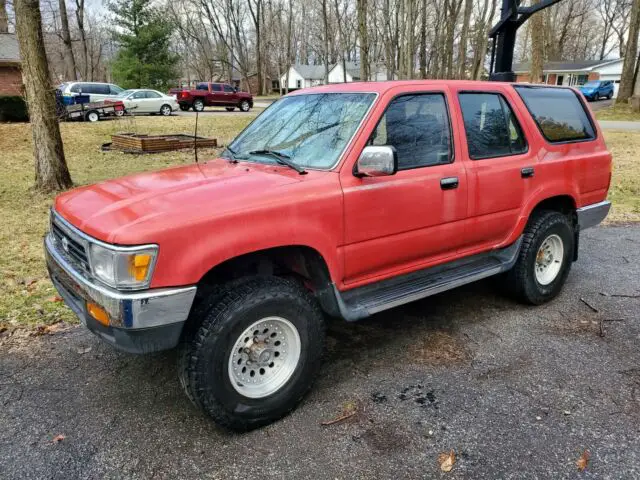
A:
[456,88,538,254]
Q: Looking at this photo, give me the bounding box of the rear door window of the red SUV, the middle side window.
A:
[459,93,527,160]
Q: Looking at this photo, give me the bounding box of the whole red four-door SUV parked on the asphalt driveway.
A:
[45,81,611,430]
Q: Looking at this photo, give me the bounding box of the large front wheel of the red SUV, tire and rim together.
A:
[179,277,325,431]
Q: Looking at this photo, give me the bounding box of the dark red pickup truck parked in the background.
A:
[175,82,253,112]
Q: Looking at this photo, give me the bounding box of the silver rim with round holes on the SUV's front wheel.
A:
[228,317,301,398]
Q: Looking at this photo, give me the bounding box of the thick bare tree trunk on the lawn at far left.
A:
[14,0,72,191]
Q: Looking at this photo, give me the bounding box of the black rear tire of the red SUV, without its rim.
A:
[505,210,575,305]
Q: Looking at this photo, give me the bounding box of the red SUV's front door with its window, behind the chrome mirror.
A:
[341,87,467,287]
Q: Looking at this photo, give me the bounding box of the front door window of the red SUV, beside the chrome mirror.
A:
[369,93,453,170]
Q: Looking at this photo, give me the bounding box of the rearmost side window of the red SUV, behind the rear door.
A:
[514,86,596,143]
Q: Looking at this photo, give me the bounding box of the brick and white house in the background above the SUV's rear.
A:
[513,58,624,96]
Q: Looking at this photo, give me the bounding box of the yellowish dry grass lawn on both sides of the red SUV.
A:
[0,118,640,332]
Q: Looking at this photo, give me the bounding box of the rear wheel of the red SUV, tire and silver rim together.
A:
[506,210,575,305]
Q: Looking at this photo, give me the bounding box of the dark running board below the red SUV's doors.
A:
[334,237,522,322]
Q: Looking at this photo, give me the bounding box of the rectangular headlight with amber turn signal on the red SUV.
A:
[90,244,158,290]
